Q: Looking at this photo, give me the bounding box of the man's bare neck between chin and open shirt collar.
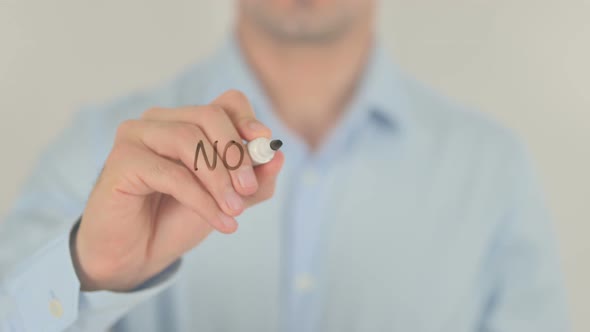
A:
[237,12,373,149]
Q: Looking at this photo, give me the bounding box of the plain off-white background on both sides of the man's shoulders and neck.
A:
[0,0,590,332]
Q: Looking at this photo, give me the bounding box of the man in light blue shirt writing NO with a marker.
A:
[0,0,567,332]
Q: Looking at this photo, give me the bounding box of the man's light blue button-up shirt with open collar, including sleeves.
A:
[0,40,569,332]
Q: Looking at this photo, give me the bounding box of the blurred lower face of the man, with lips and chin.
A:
[239,0,375,42]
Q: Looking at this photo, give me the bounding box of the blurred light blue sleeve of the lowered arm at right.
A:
[480,144,570,332]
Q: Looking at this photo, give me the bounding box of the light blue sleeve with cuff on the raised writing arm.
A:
[0,105,180,332]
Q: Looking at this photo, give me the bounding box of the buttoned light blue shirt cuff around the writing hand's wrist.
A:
[0,226,181,331]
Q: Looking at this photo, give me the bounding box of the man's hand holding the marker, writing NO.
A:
[72,91,284,291]
